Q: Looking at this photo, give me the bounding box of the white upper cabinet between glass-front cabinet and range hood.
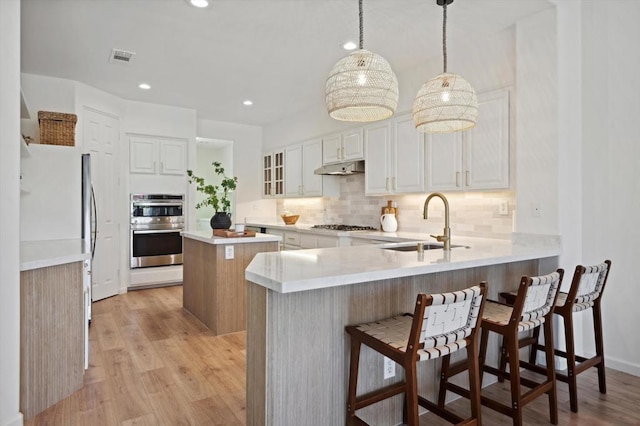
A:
[284,139,323,197]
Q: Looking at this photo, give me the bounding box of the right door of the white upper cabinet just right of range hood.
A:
[391,114,425,193]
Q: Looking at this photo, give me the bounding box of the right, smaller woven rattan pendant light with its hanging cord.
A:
[413,0,478,133]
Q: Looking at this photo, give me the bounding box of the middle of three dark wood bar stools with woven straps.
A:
[438,269,564,426]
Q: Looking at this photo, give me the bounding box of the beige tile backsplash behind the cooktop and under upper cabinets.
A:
[277,174,516,239]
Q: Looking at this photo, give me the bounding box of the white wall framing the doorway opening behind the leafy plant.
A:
[195,120,275,229]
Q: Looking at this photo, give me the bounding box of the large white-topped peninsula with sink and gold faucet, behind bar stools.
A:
[245,234,560,425]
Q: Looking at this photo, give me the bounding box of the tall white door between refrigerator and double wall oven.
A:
[83,107,124,301]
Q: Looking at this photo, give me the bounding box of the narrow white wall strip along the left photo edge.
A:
[0,0,22,426]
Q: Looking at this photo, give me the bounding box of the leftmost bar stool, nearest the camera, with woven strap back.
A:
[346,282,486,426]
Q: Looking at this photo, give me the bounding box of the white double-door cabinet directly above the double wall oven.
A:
[129,138,187,175]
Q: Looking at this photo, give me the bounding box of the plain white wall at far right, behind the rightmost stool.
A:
[582,0,640,375]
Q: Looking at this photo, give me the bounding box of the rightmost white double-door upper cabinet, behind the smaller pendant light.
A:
[426,89,509,191]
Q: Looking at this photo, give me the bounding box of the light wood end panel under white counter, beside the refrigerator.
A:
[20,262,84,418]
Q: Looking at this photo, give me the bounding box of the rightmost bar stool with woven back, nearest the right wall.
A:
[500,260,611,413]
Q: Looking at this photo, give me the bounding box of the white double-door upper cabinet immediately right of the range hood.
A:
[364,114,424,195]
